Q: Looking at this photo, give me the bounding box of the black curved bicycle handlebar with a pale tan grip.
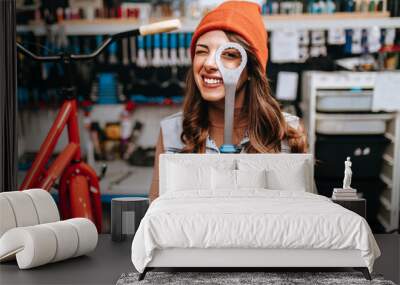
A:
[17,19,181,62]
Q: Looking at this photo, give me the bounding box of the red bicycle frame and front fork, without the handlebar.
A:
[20,98,102,232]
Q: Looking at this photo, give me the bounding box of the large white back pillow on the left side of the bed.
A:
[167,162,211,191]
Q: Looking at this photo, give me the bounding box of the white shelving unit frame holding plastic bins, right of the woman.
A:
[301,71,400,231]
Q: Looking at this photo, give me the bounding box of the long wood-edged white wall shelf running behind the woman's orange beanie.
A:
[17,12,400,36]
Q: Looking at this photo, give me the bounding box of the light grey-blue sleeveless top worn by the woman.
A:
[161,112,299,153]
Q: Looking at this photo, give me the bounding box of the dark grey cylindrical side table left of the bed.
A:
[111,197,149,241]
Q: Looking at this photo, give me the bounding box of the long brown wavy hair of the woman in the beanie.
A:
[181,32,307,153]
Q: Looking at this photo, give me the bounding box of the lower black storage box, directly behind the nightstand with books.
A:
[315,179,386,233]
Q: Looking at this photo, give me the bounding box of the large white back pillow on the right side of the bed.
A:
[266,163,309,192]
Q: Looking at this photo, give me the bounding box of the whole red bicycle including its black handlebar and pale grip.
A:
[17,20,180,232]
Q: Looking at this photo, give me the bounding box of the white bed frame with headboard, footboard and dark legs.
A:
[139,154,371,280]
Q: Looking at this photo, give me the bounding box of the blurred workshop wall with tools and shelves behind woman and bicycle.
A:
[16,0,400,233]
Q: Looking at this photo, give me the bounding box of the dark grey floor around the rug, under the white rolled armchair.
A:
[0,235,400,285]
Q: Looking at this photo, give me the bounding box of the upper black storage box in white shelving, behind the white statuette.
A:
[315,135,390,179]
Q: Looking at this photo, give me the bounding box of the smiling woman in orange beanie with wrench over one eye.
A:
[149,1,306,201]
